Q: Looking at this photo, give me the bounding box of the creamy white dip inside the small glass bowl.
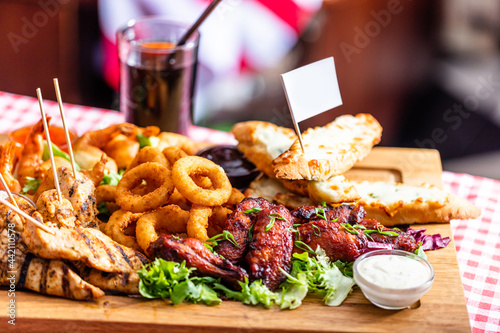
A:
[358,255,431,289]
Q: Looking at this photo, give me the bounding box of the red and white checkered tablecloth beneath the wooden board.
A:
[0,92,500,332]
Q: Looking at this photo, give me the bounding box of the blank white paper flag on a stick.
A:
[281,57,342,122]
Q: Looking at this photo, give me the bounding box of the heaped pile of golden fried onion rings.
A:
[96,141,245,253]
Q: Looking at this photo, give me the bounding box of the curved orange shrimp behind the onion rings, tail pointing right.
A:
[73,123,160,172]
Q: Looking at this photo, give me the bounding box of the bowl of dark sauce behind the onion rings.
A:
[197,145,260,190]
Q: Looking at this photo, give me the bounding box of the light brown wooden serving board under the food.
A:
[0,147,470,333]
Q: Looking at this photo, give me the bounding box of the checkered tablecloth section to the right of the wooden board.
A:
[443,171,500,332]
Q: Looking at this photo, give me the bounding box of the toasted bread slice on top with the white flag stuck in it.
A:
[273,113,382,180]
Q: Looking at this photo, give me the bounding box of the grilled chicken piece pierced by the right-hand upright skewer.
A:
[57,167,98,228]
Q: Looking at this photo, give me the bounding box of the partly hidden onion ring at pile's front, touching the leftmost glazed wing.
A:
[135,205,190,253]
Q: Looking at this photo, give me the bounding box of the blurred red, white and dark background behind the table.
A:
[0,0,500,179]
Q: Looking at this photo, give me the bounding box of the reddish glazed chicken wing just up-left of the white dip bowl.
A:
[297,220,368,262]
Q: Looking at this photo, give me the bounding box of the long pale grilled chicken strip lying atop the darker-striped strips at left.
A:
[22,212,148,273]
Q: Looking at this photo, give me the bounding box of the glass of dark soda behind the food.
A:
[120,37,197,135]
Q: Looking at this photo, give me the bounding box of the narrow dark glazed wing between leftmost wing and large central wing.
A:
[215,198,270,265]
